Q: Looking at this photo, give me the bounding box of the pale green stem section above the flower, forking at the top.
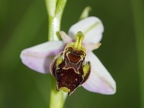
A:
[46,0,67,41]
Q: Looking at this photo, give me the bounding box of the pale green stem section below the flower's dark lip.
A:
[50,76,67,108]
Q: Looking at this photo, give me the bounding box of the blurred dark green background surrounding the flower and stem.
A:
[0,0,144,108]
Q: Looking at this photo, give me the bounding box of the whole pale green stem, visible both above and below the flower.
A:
[46,0,67,108]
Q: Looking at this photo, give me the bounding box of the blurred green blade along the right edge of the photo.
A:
[132,0,144,108]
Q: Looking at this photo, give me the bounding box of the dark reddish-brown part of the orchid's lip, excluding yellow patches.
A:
[50,48,90,95]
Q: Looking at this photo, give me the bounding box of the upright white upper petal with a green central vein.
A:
[68,16,104,43]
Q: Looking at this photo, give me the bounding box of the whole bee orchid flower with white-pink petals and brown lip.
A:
[20,16,116,95]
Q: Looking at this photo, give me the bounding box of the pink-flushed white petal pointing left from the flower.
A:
[20,41,63,73]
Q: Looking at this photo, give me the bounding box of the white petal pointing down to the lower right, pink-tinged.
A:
[82,52,116,94]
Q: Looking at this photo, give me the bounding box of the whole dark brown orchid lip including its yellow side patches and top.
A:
[50,31,91,95]
